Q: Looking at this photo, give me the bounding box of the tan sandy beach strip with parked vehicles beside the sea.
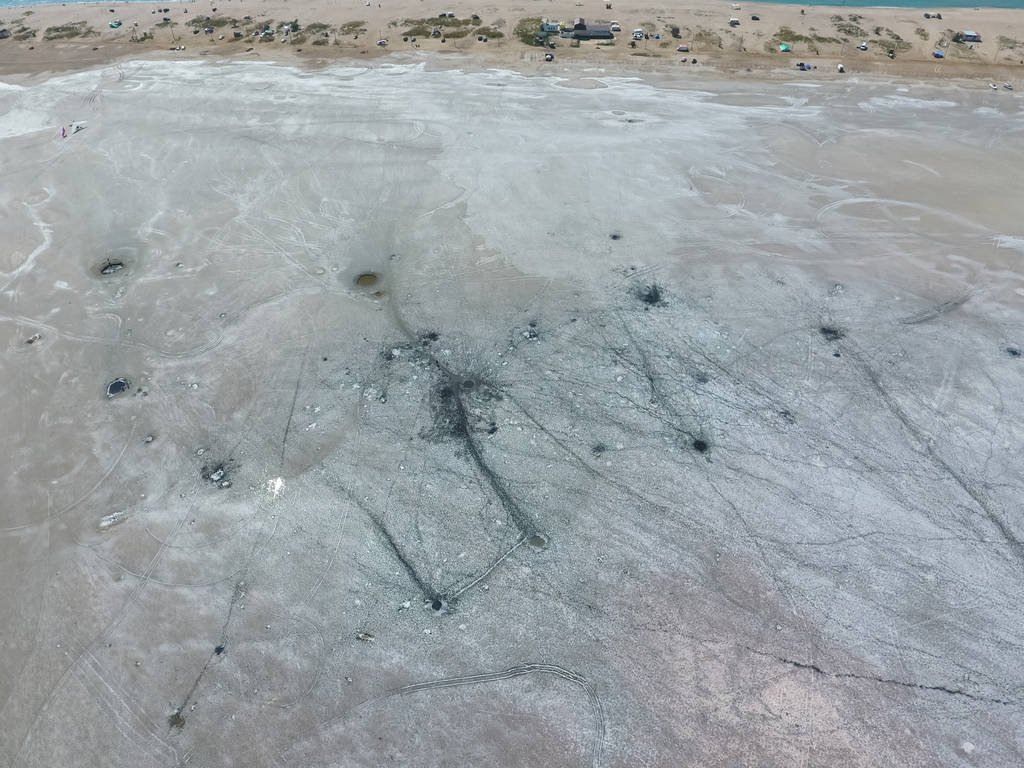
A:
[0,0,1024,82]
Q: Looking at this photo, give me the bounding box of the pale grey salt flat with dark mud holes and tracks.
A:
[0,60,1024,767]
